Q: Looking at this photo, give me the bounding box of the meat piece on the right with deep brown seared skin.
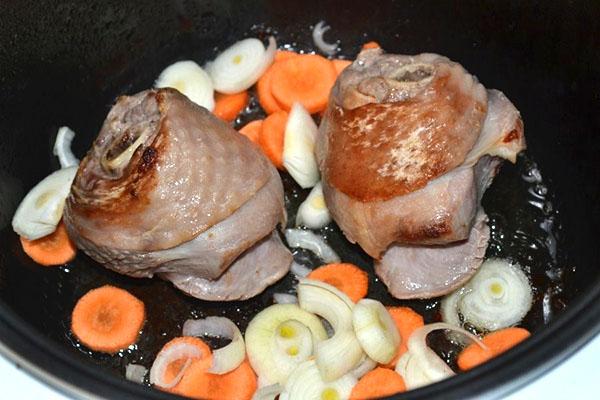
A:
[316,49,525,299]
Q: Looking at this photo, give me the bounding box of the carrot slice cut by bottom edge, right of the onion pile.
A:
[350,367,406,400]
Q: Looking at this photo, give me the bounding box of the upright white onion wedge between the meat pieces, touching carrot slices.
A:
[283,103,320,189]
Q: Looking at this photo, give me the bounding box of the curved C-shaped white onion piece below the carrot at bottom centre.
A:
[297,279,364,382]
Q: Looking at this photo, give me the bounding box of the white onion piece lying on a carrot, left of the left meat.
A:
[12,167,77,240]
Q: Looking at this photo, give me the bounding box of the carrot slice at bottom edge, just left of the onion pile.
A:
[173,360,257,400]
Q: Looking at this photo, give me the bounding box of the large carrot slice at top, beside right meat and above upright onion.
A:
[271,54,337,114]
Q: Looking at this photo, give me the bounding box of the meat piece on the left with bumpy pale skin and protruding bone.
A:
[64,89,292,300]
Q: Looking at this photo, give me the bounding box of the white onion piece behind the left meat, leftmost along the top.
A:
[154,60,215,111]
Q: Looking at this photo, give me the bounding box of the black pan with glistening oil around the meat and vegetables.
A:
[0,0,600,399]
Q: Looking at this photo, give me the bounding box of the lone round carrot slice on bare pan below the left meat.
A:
[71,285,146,353]
